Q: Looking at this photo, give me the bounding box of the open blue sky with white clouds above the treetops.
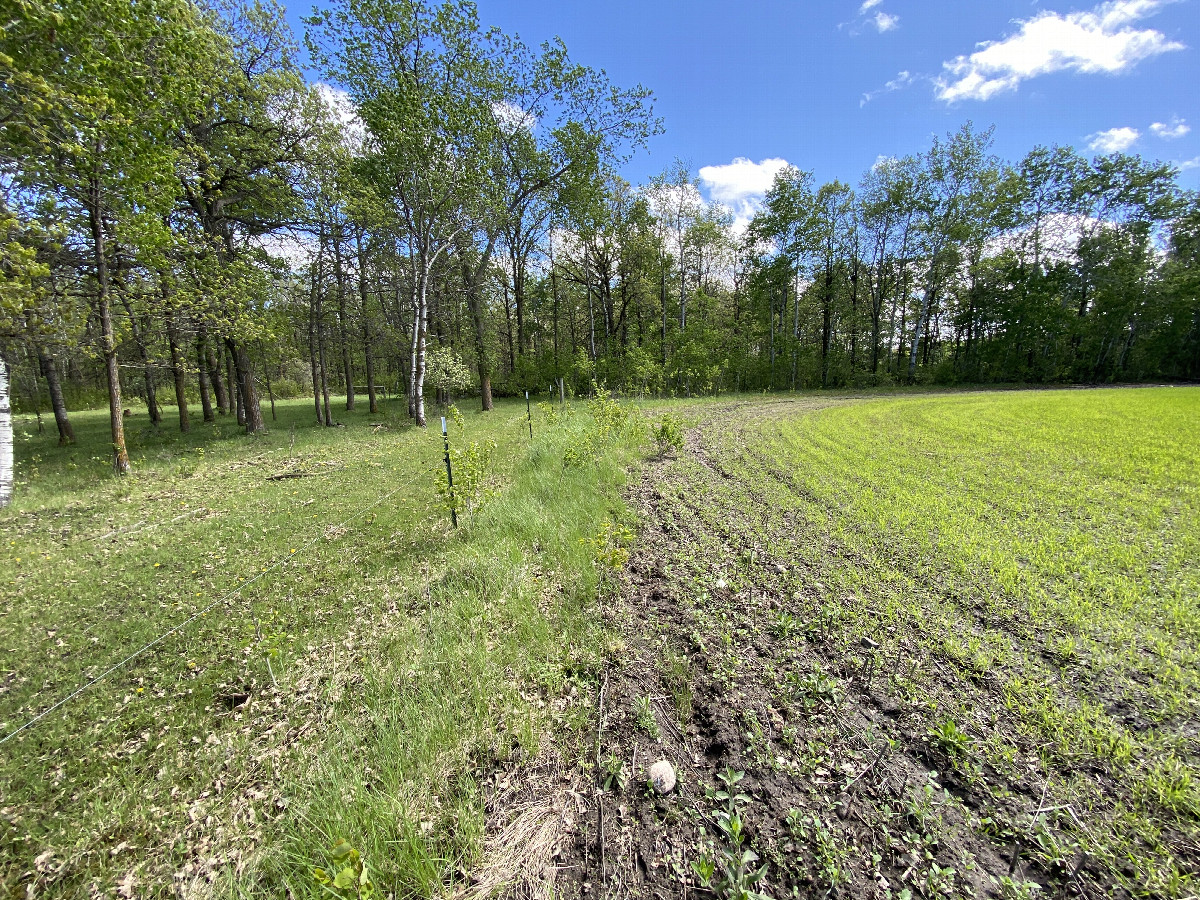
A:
[288,0,1200,211]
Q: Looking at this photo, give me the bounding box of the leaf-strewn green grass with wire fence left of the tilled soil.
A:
[0,401,644,898]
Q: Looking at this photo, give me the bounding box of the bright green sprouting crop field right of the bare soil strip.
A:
[680,388,1200,896]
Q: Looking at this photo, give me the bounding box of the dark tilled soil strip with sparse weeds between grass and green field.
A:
[468,410,1171,898]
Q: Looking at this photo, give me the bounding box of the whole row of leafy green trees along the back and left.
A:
[0,0,1200,501]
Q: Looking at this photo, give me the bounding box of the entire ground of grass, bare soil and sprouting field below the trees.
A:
[0,388,1200,900]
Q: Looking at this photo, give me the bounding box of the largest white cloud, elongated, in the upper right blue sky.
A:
[935,0,1183,103]
